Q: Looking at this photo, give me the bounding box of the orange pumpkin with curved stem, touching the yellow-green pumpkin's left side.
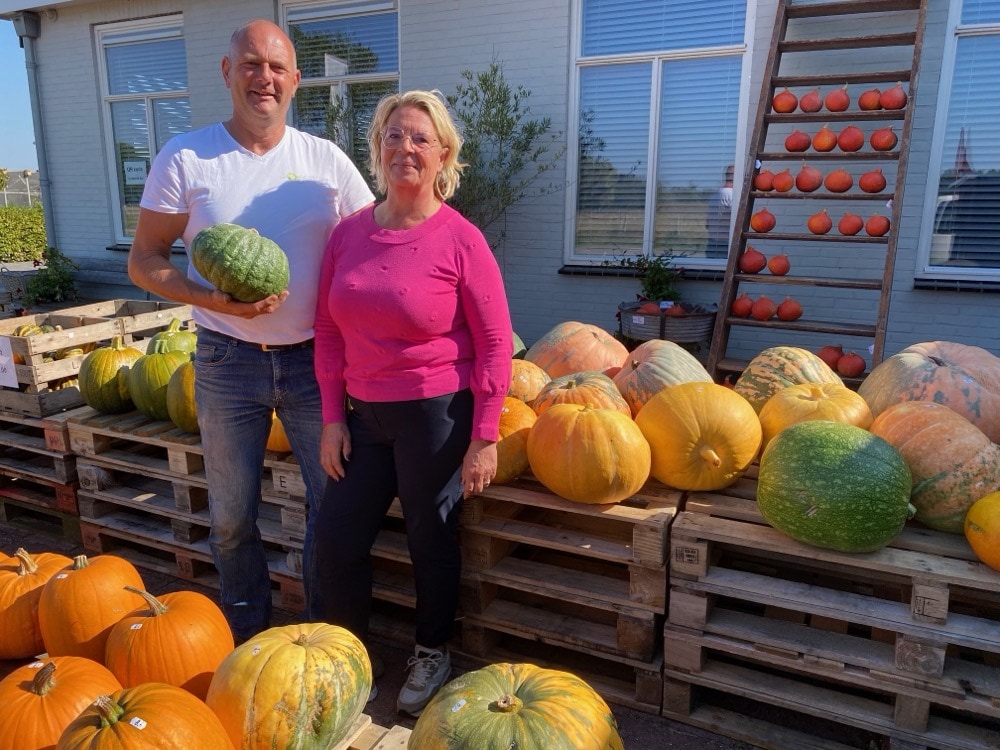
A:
[105,586,235,700]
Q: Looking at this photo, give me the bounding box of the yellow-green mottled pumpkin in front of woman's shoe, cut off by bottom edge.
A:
[407,664,624,750]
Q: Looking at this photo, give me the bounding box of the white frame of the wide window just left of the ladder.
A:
[563,0,759,270]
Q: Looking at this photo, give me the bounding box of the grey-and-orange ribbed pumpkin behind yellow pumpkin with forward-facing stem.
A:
[614,339,712,417]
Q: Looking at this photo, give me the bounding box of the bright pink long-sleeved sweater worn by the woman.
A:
[316,205,513,440]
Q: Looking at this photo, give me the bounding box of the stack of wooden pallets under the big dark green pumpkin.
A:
[663,488,1000,749]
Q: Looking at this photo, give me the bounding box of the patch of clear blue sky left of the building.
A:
[0,20,38,171]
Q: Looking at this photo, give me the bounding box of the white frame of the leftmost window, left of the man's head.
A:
[94,13,194,245]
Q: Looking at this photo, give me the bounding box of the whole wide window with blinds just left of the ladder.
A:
[569,0,746,265]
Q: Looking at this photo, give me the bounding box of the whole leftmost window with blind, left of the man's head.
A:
[97,16,191,243]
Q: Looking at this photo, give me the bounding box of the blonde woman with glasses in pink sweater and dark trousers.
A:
[316,91,513,716]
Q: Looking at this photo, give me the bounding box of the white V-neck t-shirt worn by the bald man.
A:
[140,123,374,344]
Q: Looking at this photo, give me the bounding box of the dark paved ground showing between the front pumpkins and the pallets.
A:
[0,522,753,750]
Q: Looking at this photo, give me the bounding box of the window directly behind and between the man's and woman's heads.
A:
[287,0,399,184]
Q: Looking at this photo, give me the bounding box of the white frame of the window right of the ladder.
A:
[915,2,1000,282]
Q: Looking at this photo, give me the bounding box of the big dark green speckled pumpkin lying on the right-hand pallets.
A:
[757,421,913,552]
